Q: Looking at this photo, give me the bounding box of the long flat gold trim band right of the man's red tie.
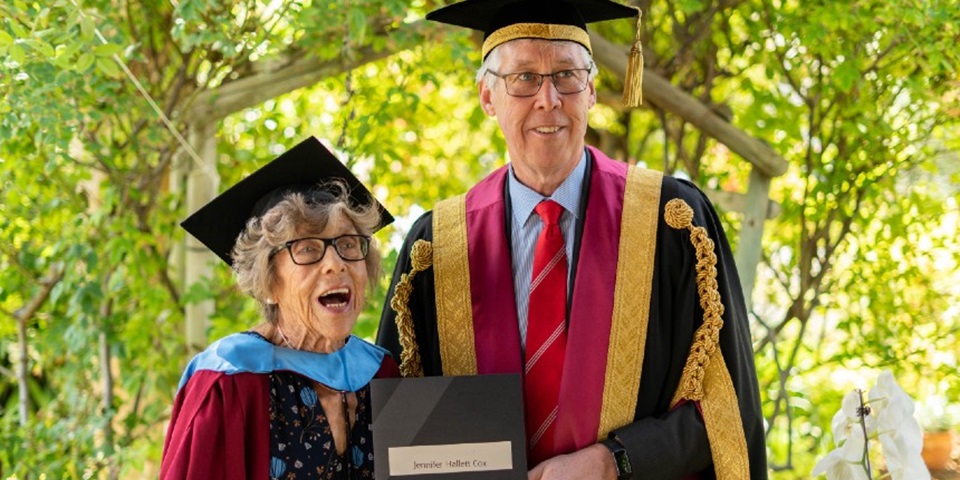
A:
[597,167,663,439]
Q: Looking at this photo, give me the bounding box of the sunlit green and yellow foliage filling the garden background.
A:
[0,0,960,478]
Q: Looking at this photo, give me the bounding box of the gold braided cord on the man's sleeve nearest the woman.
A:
[390,240,433,377]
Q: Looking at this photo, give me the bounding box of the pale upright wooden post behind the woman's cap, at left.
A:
[183,121,220,354]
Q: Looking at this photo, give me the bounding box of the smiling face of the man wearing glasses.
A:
[479,40,597,189]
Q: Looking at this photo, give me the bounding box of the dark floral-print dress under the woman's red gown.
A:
[260,340,373,480]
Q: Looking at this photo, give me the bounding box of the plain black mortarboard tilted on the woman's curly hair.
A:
[180,137,393,265]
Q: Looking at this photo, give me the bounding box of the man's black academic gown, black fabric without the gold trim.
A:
[377,152,767,479]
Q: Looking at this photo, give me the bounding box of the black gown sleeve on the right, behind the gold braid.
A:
[613,177,767,480]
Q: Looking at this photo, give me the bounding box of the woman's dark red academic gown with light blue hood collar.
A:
[160,334,399,480]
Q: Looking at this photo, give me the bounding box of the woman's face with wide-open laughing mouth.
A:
[273,215,367,351]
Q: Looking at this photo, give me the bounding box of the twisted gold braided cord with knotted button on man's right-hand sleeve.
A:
[664,198,723,404]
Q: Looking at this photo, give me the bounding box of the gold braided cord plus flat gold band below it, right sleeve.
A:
[664,198,750,480]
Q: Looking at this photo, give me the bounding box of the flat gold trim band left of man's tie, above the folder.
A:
[433,195,477,376]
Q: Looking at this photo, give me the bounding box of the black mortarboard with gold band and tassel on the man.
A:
[427,0,643,107]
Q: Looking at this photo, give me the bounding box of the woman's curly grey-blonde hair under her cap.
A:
[230,180,381,324]
